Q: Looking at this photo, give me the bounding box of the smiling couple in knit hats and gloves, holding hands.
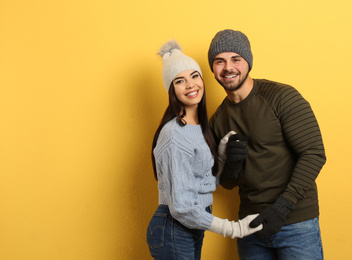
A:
[147,30,326,260]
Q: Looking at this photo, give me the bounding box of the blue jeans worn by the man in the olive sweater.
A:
[237,218,324,260]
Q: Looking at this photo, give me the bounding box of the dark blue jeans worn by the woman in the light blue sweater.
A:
[147,205,210,260]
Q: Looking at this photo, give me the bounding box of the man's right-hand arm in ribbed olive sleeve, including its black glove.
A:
[250,85,326,236]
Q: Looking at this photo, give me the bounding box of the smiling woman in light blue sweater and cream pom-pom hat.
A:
[147,41,261,260]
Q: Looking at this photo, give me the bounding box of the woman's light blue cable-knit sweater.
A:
[153,118,216,230]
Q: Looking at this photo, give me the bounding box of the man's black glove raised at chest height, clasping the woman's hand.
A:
[222,134,248,179]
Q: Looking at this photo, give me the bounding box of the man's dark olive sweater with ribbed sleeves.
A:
[210,79,326,224]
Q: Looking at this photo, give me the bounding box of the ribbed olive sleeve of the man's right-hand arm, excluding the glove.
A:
[278,88,326,204]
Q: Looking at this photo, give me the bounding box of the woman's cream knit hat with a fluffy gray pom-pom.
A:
[158,40,202,92]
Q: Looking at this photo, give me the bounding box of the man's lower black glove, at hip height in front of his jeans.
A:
[249,195,295,237]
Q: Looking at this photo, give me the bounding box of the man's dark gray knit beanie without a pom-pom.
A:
[208,29,253,71]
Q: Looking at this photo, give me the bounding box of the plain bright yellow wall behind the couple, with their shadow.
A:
[0,0,352,260]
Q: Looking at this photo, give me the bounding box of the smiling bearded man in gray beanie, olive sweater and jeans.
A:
[208,30,326,260]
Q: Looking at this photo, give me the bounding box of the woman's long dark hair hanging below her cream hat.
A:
[152,79,218,180]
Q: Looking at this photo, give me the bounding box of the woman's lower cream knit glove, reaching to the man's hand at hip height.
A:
[209,214,263,238]
